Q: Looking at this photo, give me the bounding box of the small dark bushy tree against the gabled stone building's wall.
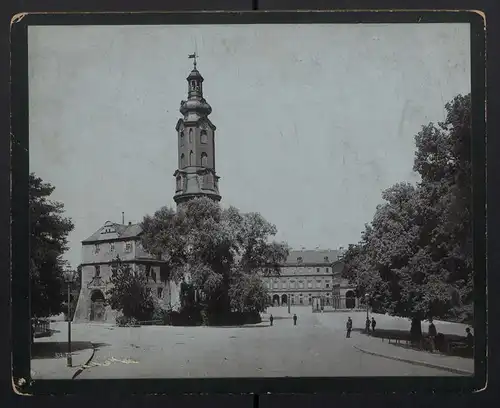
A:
[106,256,155,321]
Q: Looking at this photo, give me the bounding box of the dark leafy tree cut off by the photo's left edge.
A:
[29,173,74,317]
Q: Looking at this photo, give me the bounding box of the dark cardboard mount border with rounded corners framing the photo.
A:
[11,10,487,395]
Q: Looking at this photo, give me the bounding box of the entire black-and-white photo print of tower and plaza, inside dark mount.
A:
[28,23,475,381]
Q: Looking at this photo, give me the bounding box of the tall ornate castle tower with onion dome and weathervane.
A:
[174,54,221,205]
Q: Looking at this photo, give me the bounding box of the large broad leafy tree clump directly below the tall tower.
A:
[142,198,288,322]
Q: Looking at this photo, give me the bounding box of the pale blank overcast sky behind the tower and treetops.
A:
[29,24,470,267]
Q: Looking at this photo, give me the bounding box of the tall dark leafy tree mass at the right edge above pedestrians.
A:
[343,95,473,336]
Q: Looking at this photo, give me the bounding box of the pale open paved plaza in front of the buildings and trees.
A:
[32,307,473,380]
